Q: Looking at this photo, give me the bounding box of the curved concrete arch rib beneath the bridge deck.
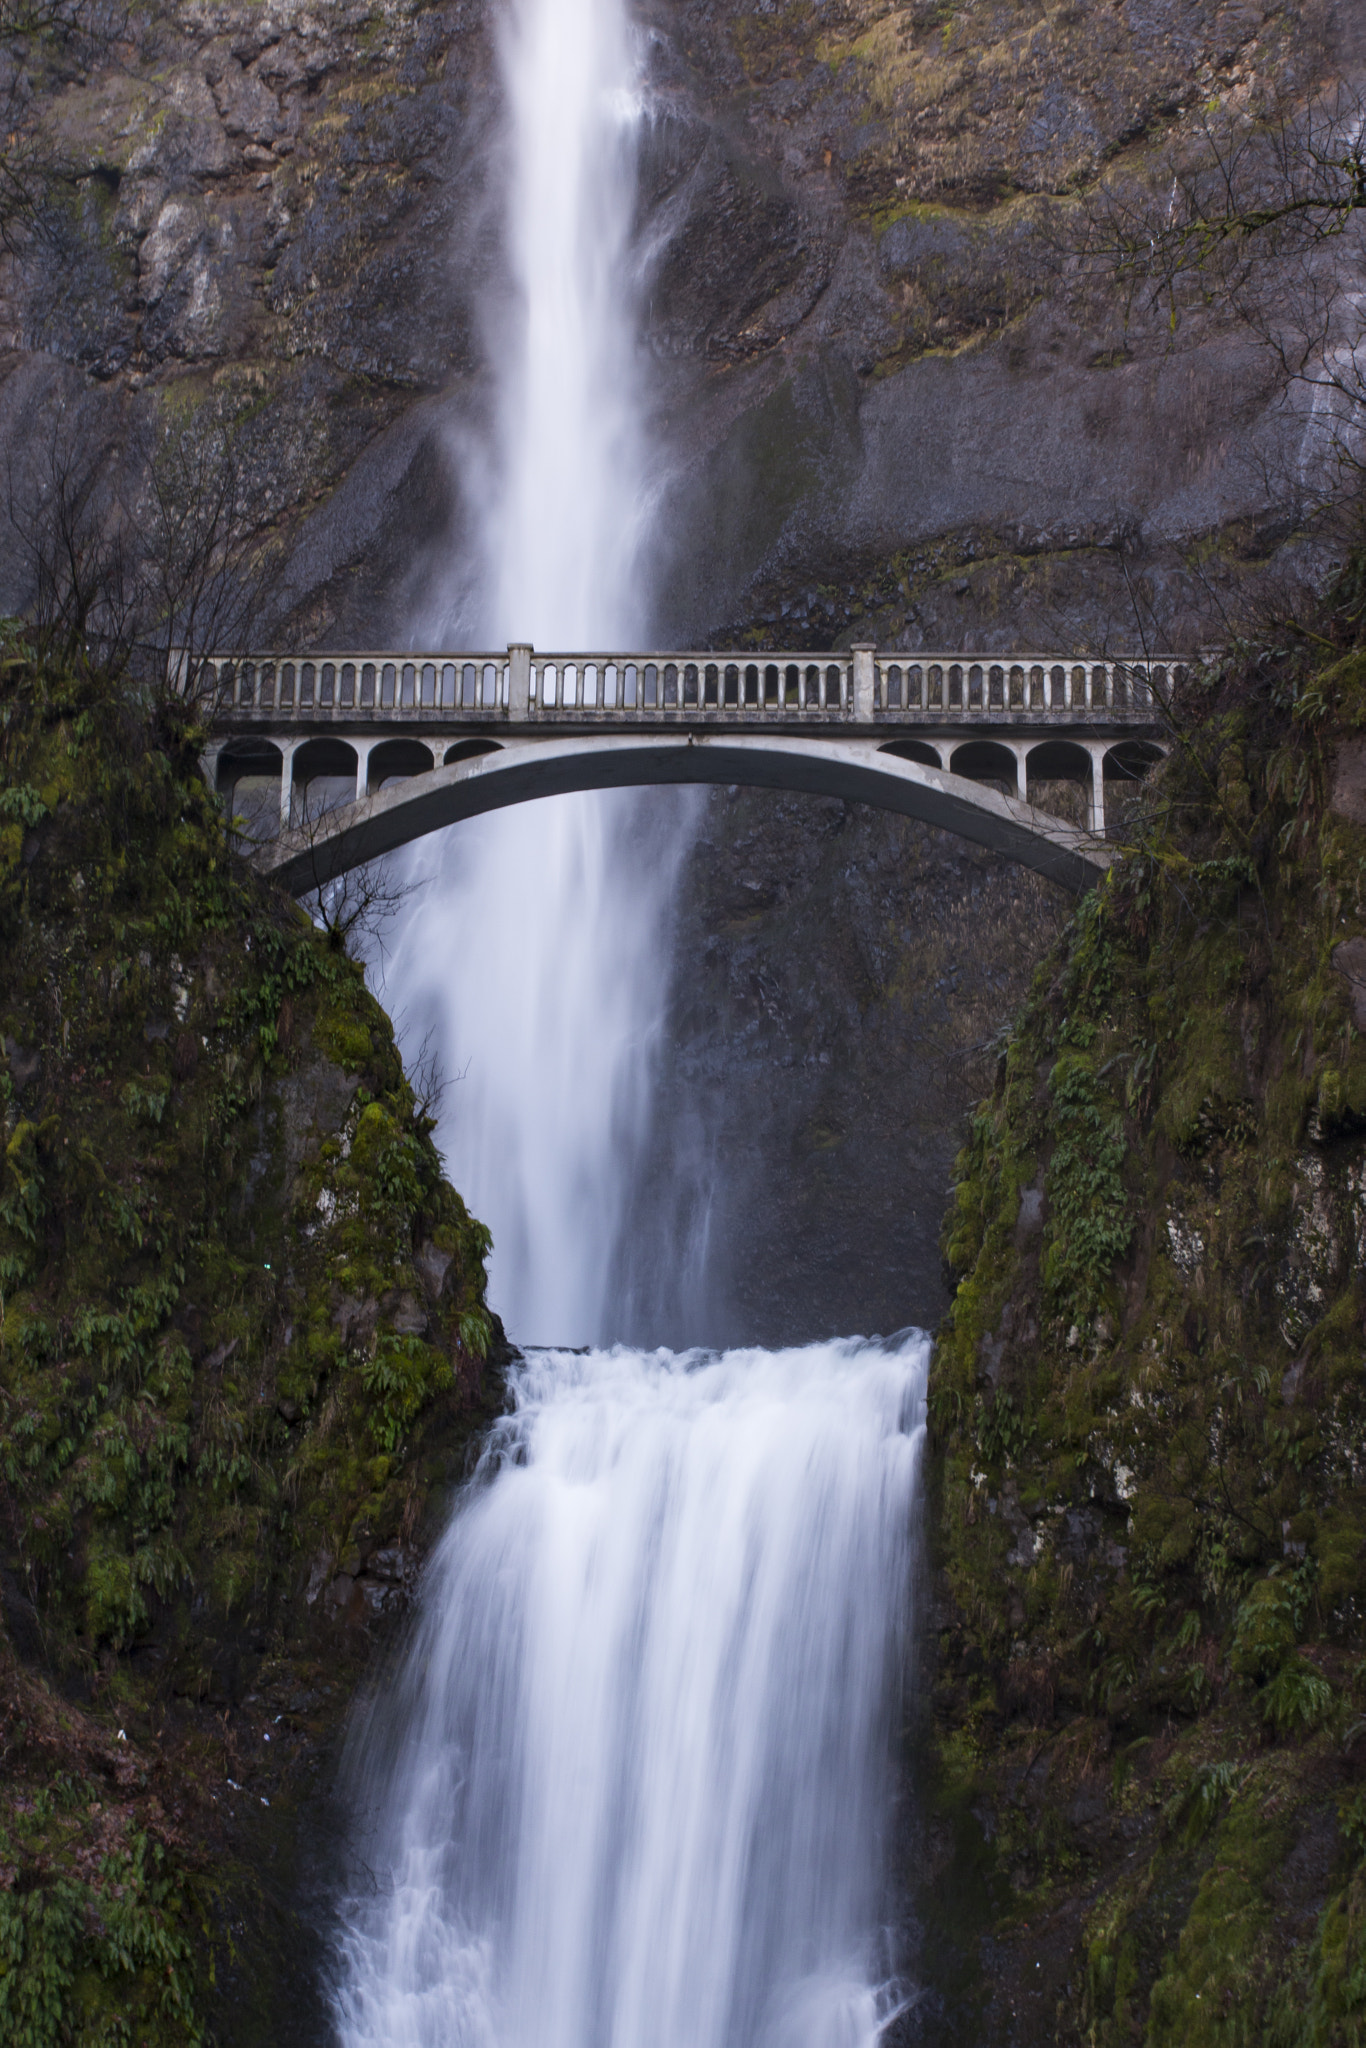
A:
[256,733,1112,895]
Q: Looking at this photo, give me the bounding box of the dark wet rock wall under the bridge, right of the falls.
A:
[621,788,1071,1346]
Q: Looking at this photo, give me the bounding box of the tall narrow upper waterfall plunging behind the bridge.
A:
[385,0,698,1343]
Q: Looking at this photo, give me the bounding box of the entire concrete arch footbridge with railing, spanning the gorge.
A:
[190,645,1182,893]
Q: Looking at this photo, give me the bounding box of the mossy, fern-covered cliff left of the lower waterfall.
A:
[0,629,502,2048]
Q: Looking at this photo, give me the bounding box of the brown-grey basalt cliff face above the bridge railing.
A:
[0,0,1362,645]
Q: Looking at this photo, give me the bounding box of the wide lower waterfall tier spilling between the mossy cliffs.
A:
[336,1333,928,2048]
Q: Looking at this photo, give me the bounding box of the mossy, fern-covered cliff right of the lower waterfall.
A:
[926,567,1366,2048]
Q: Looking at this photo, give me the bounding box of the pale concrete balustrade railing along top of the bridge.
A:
[190,645,1184,725]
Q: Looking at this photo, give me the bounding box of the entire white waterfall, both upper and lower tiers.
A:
[332,0,928,2048]
